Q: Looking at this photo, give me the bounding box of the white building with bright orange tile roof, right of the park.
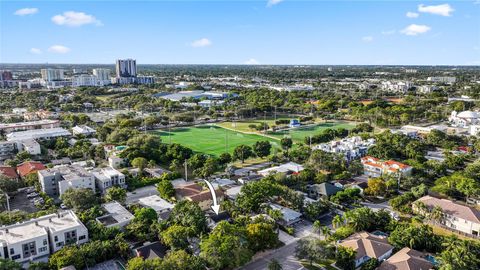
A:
[361,156,412,177]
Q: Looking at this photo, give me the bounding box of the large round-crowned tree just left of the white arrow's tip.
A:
[168,200,207,235]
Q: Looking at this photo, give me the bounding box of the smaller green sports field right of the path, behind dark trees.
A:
[268,122,355,143]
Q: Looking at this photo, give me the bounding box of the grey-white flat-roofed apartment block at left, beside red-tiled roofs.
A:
[38,165,95,197]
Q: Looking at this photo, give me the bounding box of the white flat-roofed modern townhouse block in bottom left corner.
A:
[0,211,88,266]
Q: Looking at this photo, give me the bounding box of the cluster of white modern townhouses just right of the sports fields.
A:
[313,136,375,161]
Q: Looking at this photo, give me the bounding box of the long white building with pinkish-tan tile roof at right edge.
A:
[412,196,480,237]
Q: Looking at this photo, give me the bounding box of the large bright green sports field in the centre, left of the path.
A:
[151,126,280,156]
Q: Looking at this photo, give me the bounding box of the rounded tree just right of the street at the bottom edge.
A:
[295,238,334,266]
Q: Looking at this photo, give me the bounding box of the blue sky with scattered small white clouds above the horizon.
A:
[0,0,480,65]
